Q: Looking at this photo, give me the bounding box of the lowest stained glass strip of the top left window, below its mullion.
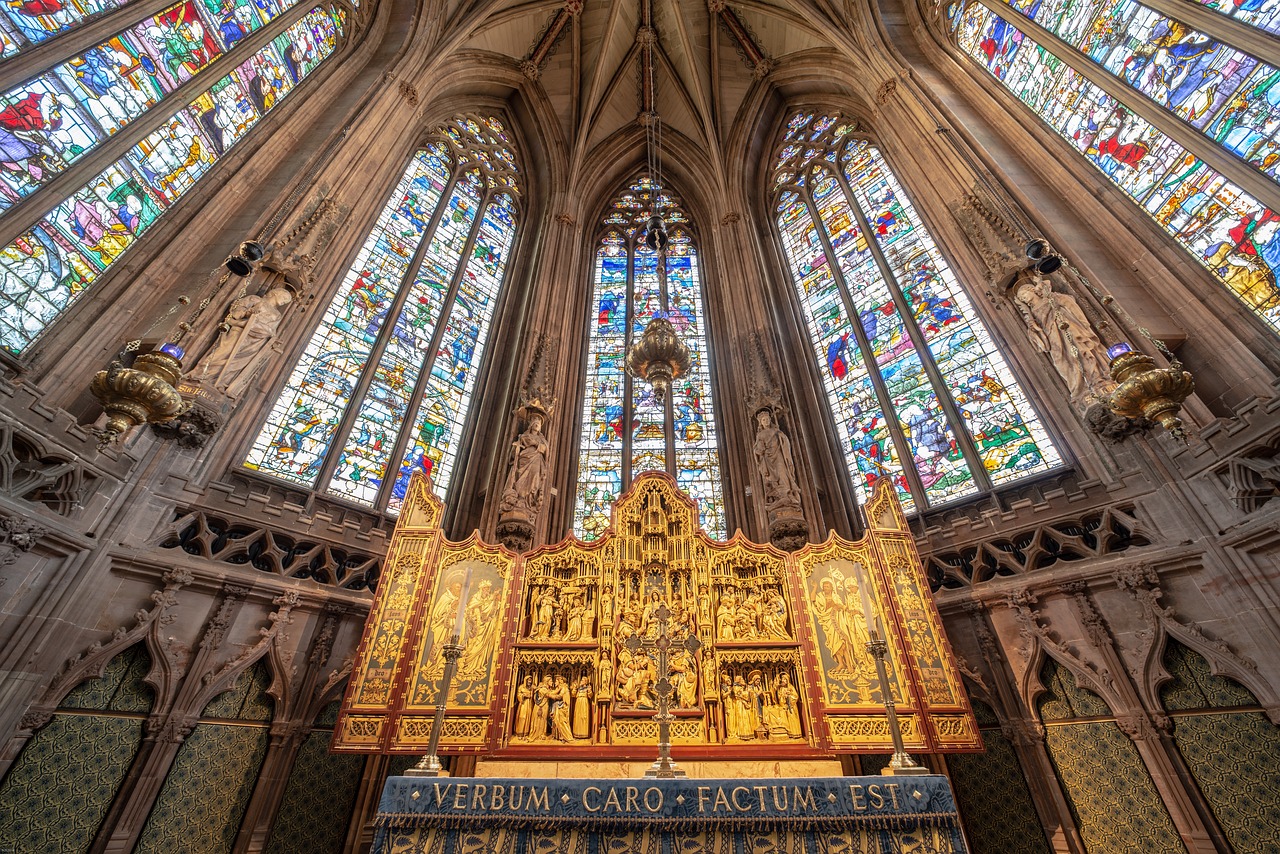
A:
[0,6,342,353]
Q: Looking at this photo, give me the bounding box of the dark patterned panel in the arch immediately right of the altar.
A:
[947,730,1050,854]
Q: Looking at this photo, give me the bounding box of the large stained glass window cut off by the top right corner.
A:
[950,0,1280,340]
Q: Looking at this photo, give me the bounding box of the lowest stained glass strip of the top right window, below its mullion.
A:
[956,4,1280,332]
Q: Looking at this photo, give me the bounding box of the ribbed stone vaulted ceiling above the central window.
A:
[463,0,831,174]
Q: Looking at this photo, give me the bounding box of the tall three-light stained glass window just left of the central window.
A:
[244,117,520,512]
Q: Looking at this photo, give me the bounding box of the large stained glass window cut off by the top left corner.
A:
[0,0,344,355]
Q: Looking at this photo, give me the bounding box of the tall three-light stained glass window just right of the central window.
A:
[773,111,1060,510]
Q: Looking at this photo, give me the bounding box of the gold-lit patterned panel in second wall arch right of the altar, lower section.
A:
[1044,721,1185,854]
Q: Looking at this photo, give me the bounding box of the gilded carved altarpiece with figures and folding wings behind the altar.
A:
[334,472,982,759]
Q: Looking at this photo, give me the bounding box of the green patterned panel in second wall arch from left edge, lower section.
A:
[133,723,269,854]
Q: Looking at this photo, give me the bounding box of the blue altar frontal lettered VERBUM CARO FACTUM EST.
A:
[372,776,966,854]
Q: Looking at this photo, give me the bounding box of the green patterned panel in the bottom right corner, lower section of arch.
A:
[1174,712,1280,854]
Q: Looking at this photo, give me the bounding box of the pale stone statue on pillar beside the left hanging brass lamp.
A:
[197,286,293,397]
